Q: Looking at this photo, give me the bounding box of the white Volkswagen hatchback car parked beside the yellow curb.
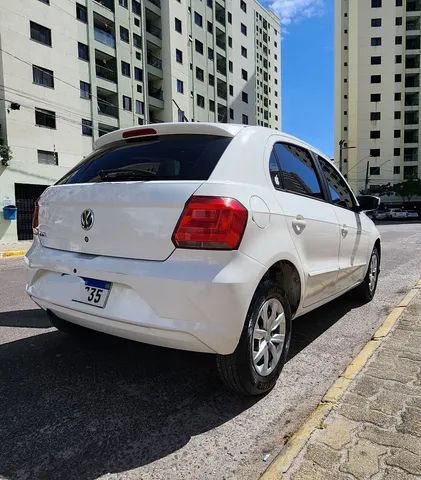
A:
[26,123,380,395]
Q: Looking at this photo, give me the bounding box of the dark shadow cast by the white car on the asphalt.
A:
[0,297,355,480]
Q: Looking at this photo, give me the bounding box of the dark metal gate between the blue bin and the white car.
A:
[15,183,48,240]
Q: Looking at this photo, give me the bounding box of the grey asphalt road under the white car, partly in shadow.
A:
[0,224,421,480]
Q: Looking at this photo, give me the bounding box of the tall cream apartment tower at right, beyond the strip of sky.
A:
[335,0,421,191]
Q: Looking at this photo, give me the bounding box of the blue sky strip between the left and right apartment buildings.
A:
[262,0,334,157]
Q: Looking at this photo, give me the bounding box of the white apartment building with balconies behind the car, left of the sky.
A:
[0,0,281,241]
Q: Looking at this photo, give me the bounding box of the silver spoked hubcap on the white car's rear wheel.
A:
[251,298,286,377]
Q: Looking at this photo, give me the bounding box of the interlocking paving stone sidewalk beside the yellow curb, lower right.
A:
[283,294,421,480]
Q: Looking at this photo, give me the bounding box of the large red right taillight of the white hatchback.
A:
[172,196,248,250]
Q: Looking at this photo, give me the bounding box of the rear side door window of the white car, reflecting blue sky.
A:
[275,143,323,198]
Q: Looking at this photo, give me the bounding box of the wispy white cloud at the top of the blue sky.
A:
[267,0,325,26]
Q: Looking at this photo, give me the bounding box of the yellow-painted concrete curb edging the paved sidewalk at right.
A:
[260,280,421,480]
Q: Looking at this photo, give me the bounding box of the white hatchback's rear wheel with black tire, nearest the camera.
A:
[216,280,291,396]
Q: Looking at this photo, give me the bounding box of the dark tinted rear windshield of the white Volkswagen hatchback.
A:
[58,135,231,185]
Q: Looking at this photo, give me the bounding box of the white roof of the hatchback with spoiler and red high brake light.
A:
[94,122,328,159]
